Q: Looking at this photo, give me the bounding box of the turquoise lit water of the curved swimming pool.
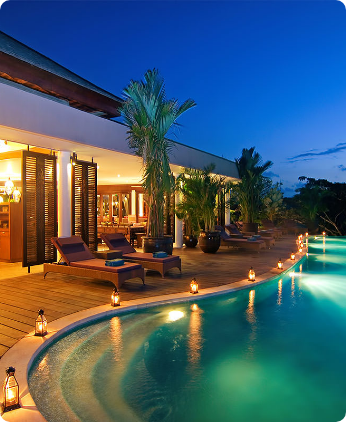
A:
[29,238,346,422]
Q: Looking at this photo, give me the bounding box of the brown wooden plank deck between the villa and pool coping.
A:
[0,236,296,356]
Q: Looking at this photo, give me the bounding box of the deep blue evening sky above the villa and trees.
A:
[0,0,346,195]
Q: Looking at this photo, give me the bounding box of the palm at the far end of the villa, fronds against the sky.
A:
[232,147,273,234]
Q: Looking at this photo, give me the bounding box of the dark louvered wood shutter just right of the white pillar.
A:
[72,160,97,251]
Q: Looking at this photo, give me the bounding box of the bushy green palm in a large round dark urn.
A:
[178,164,223,253]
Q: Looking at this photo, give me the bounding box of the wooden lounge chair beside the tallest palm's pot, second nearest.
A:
[101,233,181,278]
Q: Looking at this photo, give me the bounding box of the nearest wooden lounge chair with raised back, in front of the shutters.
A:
[43,236,144,289]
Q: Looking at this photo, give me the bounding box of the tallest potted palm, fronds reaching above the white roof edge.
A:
[121,69,196,254]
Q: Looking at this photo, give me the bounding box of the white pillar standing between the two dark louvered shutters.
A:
[58,151,72,236]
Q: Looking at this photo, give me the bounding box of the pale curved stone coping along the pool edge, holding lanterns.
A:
[0,252,307,422]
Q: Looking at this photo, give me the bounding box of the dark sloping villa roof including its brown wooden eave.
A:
[0,31,122,118]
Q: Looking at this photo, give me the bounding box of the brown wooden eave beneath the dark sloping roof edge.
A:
[0,52,121,118]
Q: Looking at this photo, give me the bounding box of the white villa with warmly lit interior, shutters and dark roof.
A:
[0,32,238,270]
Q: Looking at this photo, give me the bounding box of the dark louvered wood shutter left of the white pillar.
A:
[22,151,57,267]
